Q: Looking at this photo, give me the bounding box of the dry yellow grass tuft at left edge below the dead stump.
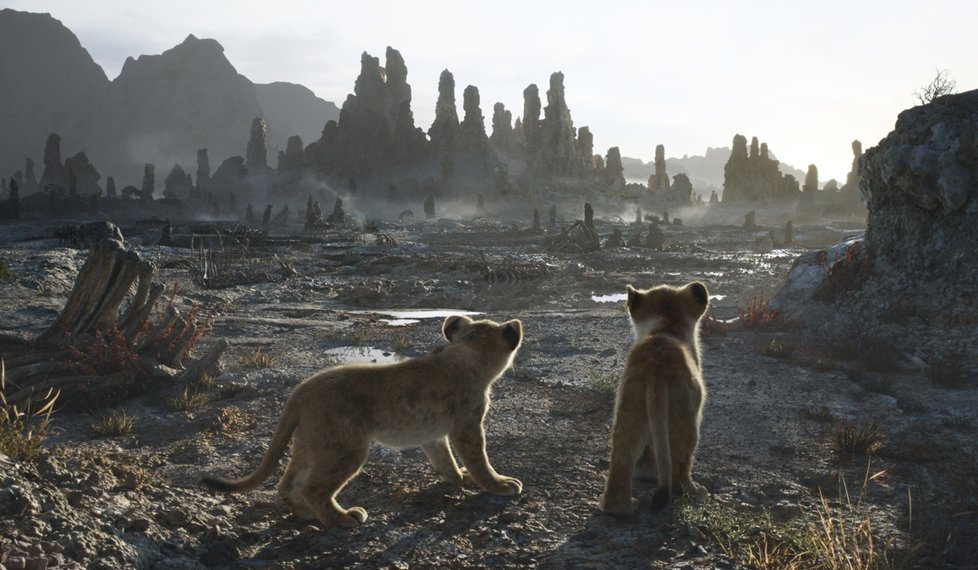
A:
[0,360,61,463]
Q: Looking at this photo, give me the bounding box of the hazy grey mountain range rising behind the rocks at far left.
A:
[0,9,339,186]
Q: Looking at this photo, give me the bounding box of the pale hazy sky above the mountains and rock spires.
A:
[7,0,978,182]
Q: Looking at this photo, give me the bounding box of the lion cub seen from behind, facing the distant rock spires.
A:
[598,283,710,515]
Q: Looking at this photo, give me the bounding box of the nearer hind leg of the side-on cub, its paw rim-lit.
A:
[301,442,369,528]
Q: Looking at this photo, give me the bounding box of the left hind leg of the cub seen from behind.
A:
[598,390,654,516]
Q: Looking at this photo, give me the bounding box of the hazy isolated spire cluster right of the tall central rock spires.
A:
[723,135,800,204]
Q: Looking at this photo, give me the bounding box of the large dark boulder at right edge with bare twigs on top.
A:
[773,91,978,360]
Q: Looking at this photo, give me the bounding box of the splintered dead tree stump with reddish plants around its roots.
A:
[0,238,228,402]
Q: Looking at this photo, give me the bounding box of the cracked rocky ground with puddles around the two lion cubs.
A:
[0,215,978,569]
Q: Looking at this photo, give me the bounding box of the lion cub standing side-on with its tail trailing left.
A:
[204,316,523,528]
